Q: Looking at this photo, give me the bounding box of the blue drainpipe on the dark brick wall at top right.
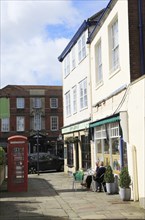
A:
[138,0,145,75]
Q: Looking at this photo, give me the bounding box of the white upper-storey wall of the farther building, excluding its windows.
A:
[62,30,91,126]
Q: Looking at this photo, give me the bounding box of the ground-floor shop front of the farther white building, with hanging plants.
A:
[62,121,91,173]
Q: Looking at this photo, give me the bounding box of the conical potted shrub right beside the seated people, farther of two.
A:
[104,165,115,194]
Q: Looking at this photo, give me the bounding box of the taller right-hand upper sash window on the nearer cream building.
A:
[110,20,119,72]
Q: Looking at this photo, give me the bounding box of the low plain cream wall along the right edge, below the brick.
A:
[128,75,145,208]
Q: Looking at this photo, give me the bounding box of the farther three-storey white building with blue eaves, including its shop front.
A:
[58,10,104,172]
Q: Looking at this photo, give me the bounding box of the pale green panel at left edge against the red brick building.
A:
[0,98,10,118]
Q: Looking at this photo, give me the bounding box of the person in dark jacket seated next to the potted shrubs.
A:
[94,161,106,192]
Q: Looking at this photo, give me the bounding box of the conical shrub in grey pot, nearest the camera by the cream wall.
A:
[119,167,131,201]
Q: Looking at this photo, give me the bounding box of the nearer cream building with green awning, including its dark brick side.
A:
[88,0,145,208]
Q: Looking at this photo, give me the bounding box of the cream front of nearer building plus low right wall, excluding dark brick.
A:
[90,1,145,208]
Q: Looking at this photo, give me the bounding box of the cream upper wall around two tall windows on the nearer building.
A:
[91,1,130,121]
